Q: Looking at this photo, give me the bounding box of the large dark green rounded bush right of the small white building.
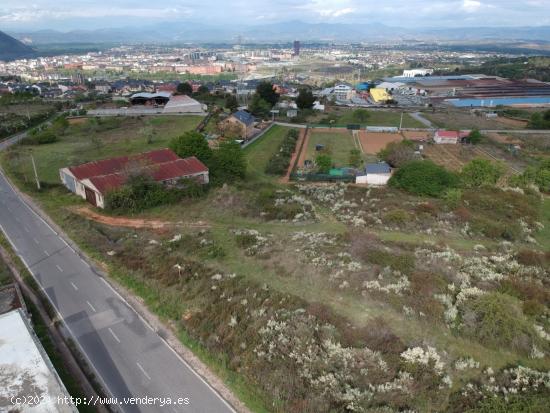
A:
[388,161,464,197]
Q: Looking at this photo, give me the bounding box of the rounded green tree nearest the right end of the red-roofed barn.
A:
[208,140,246,183]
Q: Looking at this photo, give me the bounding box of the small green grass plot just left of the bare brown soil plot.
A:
[305,130,358,167]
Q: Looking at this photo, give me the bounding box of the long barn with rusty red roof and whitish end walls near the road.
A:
[59,149,209,208]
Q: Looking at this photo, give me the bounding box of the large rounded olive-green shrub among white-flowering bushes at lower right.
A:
[462,292,534,353]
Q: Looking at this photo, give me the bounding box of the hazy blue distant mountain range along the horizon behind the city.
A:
[5,21,550,45]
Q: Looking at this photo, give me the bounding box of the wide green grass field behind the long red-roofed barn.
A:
[4,116,201,184]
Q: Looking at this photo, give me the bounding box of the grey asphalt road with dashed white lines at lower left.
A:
[0,174,234,413]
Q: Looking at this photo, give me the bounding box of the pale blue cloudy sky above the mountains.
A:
[0,0,550,31]
